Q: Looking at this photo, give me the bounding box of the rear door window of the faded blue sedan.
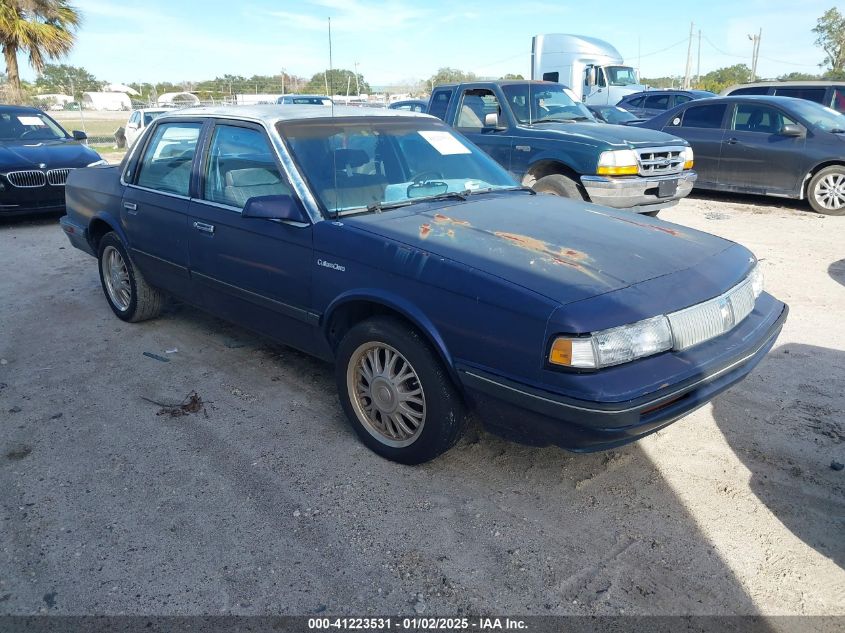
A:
[135,122,202,196]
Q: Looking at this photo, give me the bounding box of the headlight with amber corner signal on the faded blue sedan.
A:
[549,315,672,369]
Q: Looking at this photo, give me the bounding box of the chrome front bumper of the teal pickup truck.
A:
[581,170,698,213]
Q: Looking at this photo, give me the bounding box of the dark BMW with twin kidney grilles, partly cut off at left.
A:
[0,106,105,217]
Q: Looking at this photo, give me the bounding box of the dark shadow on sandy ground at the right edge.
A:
[713,344,845,566]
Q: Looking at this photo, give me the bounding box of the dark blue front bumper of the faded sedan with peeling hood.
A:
[458,302,789,452]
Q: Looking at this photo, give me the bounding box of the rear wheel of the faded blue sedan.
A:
[97,231,164,323]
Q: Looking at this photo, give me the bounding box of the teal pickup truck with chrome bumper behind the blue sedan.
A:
[428,81,696,215]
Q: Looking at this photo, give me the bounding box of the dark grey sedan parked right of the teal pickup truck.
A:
[640,96,845,215]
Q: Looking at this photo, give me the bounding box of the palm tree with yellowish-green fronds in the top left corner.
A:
[0,0,81,103]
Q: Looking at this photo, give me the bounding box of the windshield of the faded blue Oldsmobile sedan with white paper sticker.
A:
[277,117,517,215]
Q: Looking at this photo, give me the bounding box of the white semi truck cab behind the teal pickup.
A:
[531,33,645,105]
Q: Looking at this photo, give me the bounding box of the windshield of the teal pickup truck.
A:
[502,83,595,125]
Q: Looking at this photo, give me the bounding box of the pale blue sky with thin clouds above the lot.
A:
[20,0,836,86]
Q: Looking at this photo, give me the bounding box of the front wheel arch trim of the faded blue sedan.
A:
[321,289,461,389]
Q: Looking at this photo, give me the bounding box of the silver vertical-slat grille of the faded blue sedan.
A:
[666,278,754,350]
